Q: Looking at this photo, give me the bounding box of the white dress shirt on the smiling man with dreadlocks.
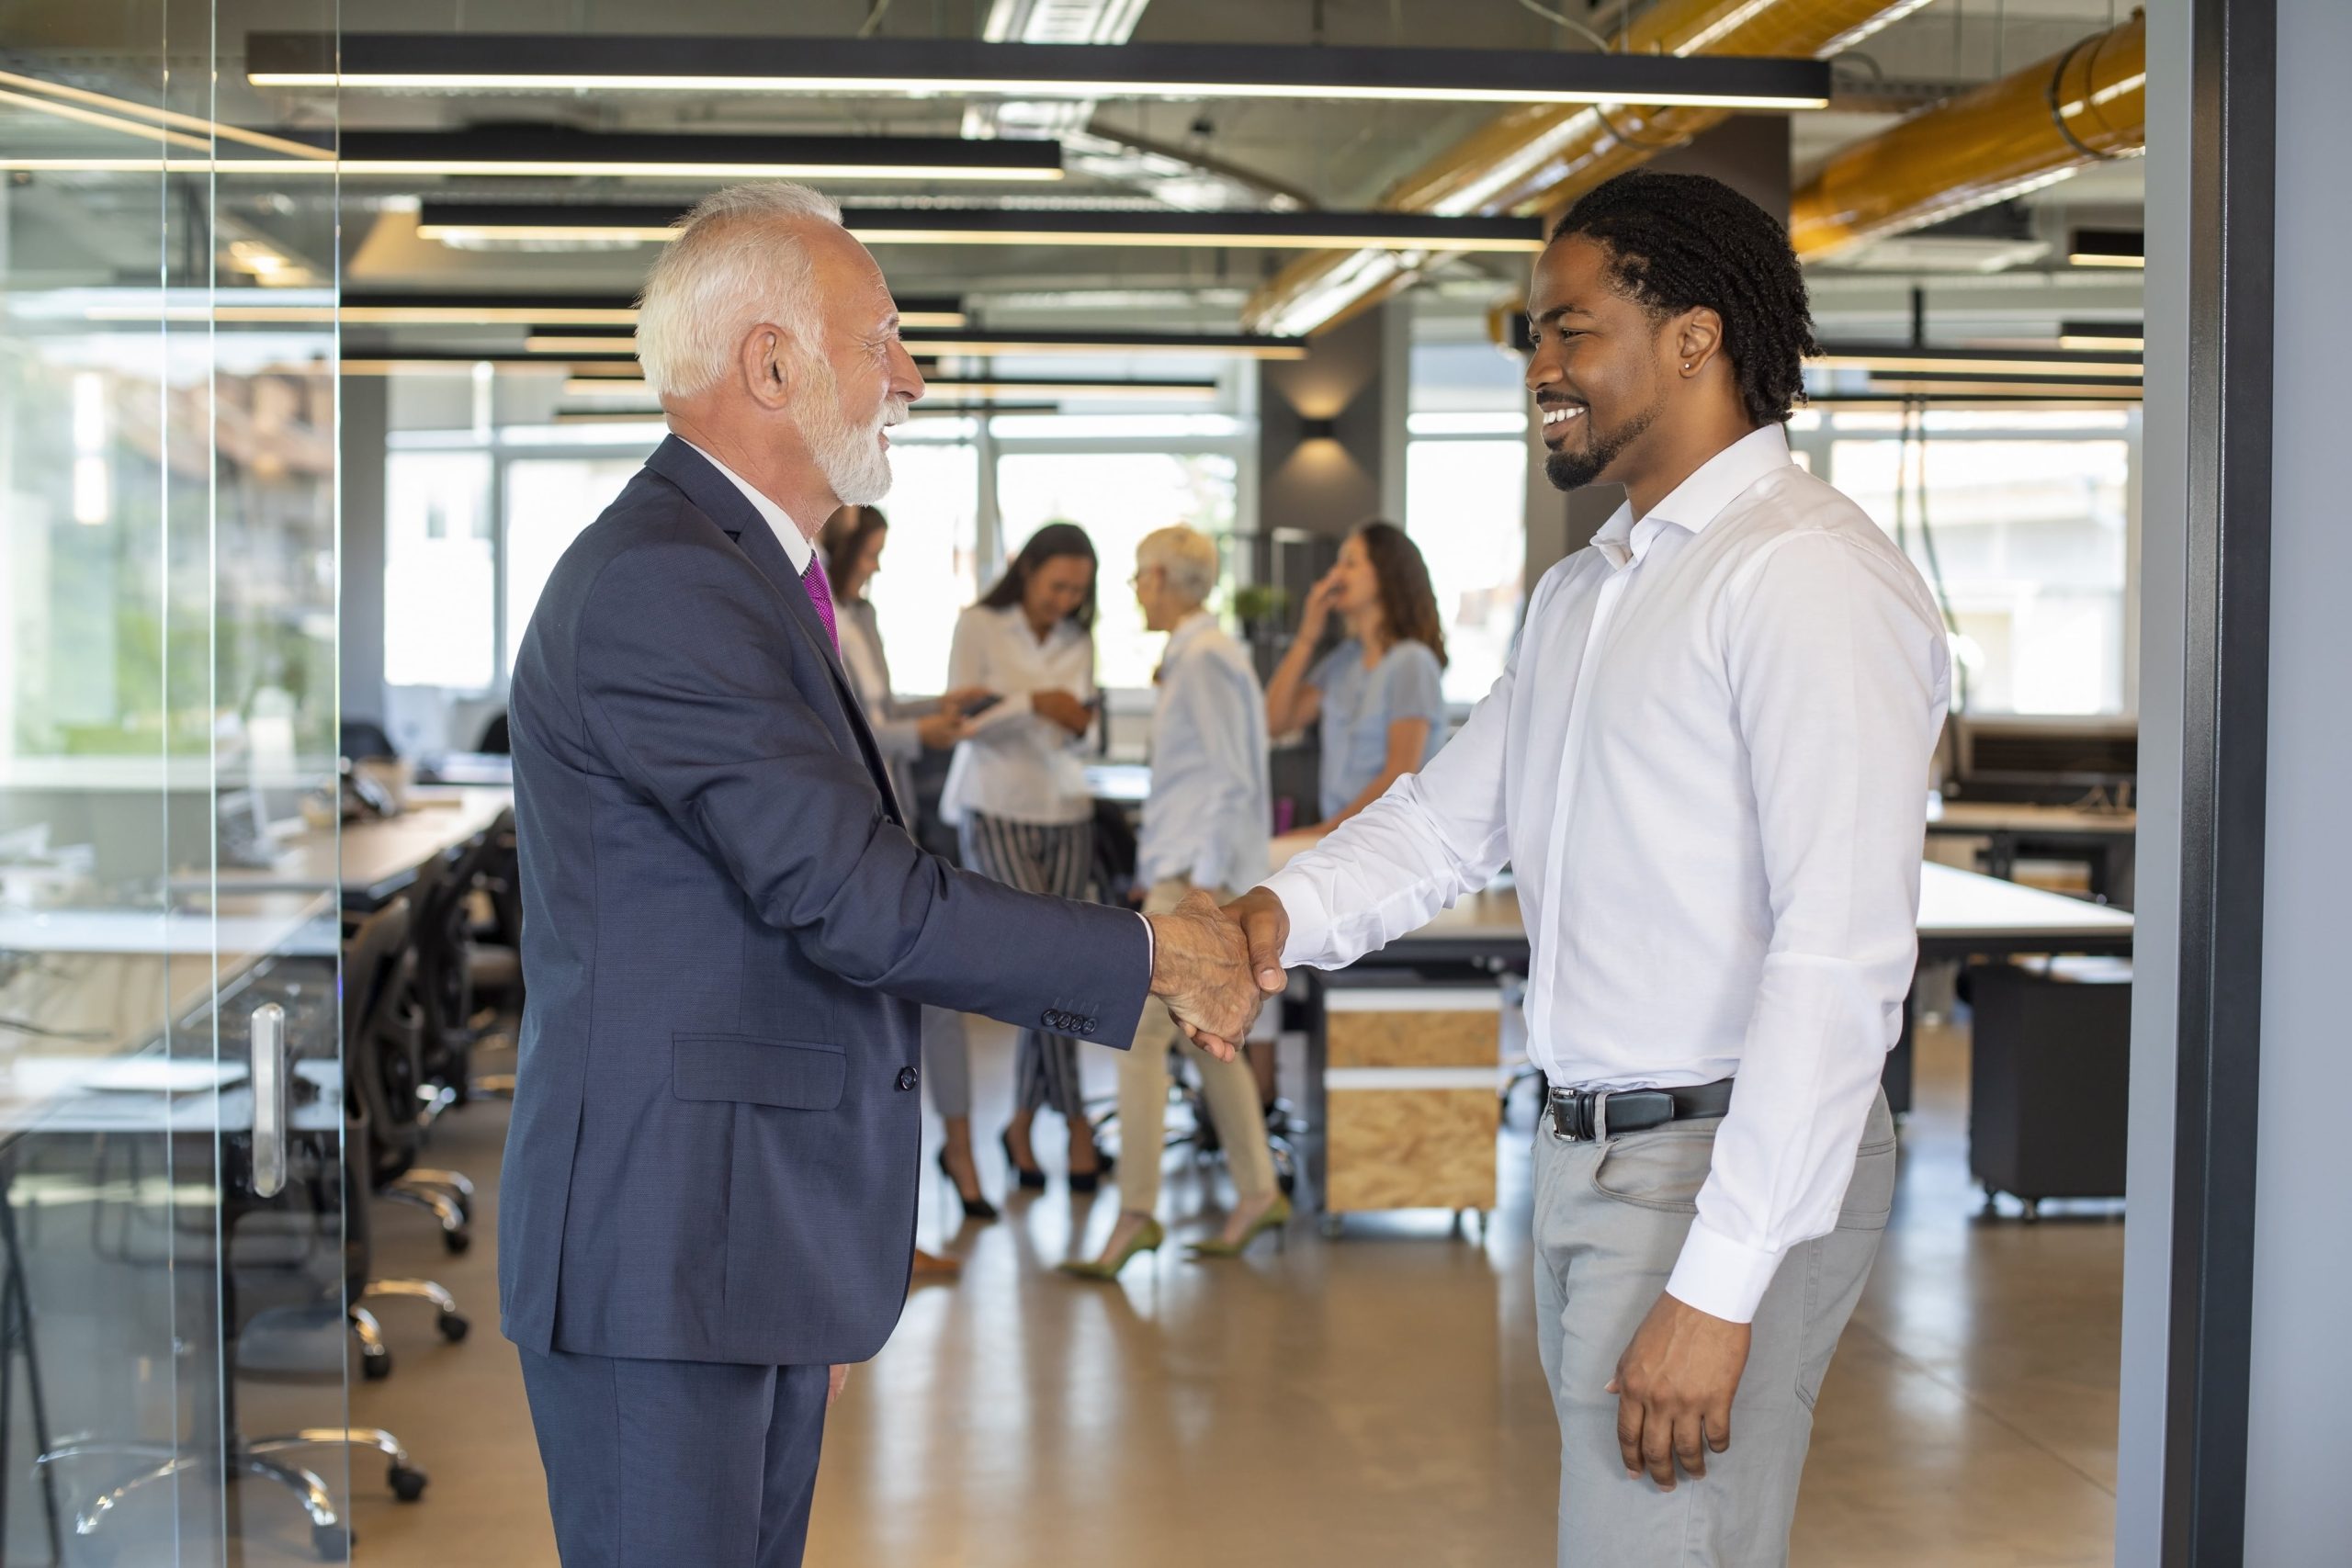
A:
[1265,425,1950,1321]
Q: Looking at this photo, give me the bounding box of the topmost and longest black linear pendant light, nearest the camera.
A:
[244,33,1830,108]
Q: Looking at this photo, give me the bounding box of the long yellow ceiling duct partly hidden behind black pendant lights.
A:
[1244,0,1927,336]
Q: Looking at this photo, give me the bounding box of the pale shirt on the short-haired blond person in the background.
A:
[1136,609,1275,888]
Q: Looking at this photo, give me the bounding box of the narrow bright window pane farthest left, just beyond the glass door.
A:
[383,451,499,691]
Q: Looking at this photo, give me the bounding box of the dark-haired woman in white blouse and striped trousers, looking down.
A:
[941,522,1105,1192]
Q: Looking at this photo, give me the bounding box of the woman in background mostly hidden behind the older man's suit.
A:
[819,505,997,1274]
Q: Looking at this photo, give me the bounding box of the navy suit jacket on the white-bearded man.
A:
[499,437,1150,1366]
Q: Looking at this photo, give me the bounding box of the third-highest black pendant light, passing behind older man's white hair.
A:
[416,202,1543,254]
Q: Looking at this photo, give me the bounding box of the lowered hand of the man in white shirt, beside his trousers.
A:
[1609,1291,1750,1491]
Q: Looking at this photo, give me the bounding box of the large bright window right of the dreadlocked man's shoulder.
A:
[1830,416,2131,715]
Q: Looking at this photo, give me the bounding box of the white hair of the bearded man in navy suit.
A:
[638,181,842,398]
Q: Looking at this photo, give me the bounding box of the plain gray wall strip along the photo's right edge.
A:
[2246,0,2352,1568]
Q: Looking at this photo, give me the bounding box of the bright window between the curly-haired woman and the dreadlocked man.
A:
[1404,440,1529,703]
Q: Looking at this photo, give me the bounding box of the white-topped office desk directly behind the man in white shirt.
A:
[1275,835,2133,1203]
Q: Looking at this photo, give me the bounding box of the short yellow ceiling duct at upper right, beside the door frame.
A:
[1790,14,2147,261]
